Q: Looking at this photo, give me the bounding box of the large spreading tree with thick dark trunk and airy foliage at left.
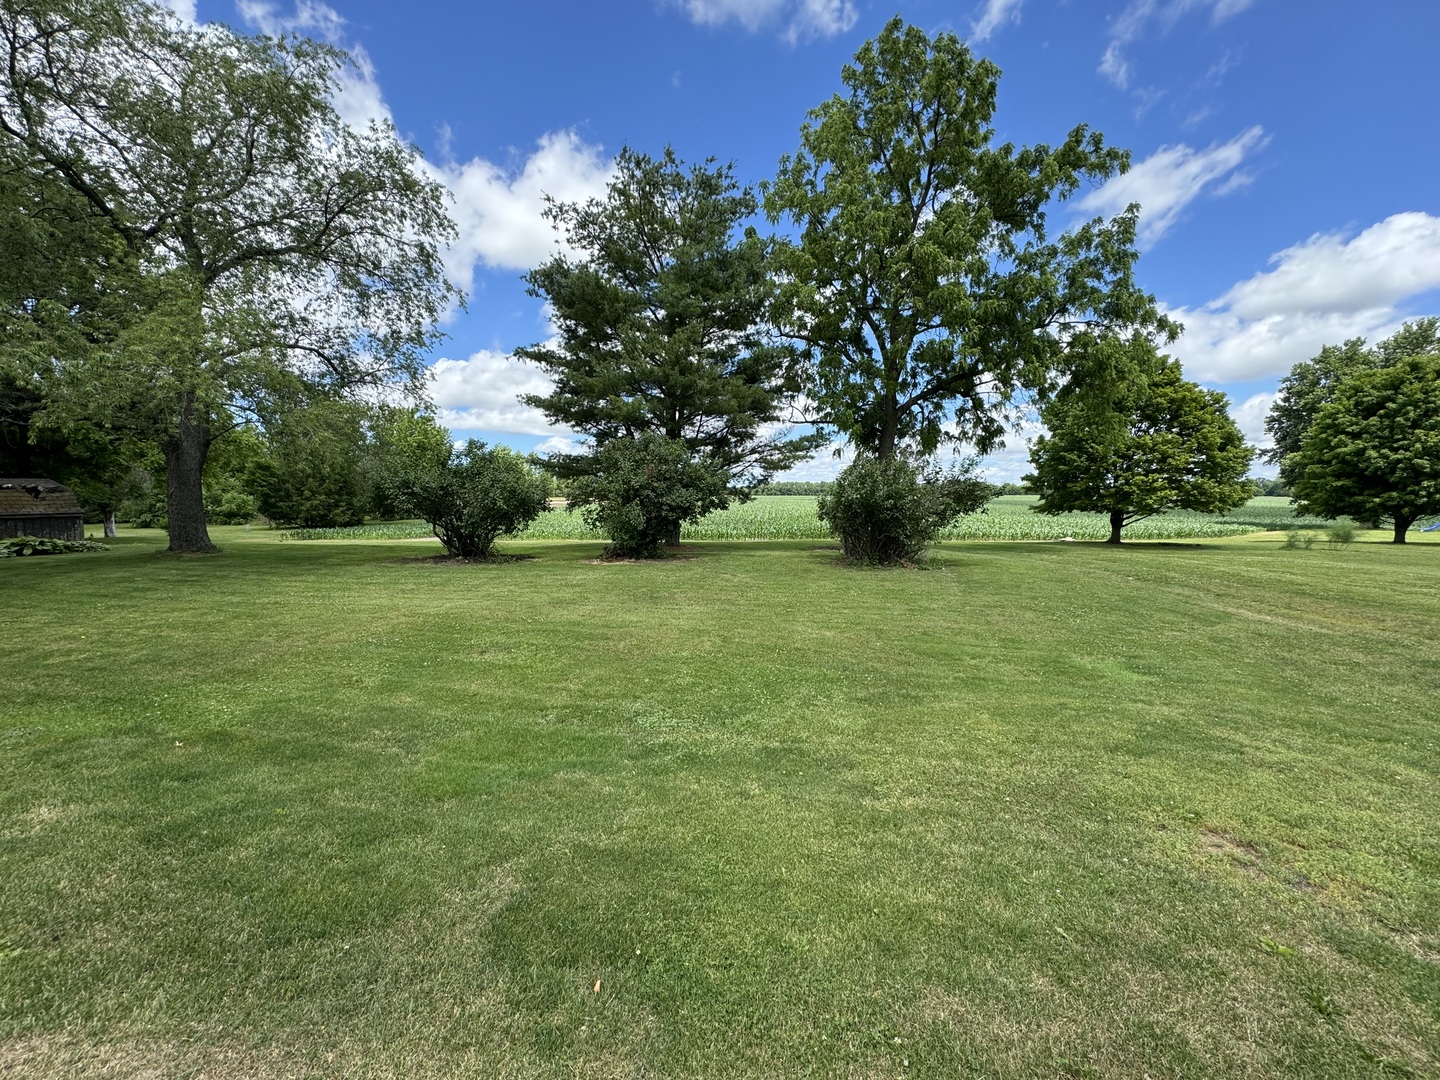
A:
[0,0,454,552]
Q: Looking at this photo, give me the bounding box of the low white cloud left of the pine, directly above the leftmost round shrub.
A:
[431,348,564,436]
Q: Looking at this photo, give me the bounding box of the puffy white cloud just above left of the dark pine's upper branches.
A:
[432,131,613,288]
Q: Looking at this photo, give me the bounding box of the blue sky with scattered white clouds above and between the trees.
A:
[170,0,1440,480]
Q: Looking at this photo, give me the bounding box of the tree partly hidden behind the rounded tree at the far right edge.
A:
[1263,317,1440,487]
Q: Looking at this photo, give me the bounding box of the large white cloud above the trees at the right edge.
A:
[1168,212,1440,382]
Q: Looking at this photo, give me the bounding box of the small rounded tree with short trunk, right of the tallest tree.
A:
[1025,359,1254,544]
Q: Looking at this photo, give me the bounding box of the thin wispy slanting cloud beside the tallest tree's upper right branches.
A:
[1076,125,1270,246]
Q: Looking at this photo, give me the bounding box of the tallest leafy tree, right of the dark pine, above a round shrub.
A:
[765,17,1175,461]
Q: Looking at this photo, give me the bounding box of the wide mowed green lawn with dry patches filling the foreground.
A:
[0,530,1440,1080]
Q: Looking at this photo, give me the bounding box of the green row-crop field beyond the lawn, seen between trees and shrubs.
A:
[287,495,1347,540]
